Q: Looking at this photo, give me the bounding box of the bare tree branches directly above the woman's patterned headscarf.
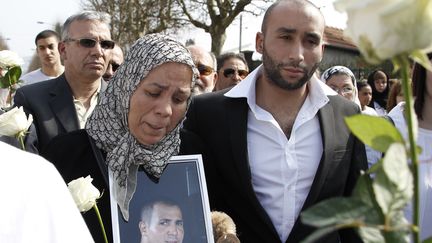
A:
[83,0,185,50]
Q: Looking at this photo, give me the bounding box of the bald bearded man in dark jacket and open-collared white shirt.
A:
[183,0,367,243]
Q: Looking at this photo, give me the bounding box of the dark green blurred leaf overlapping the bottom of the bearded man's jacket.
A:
[301,197,371,227]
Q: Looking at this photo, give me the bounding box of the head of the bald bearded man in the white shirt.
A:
[256,2,324,90]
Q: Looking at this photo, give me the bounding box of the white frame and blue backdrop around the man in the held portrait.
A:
[109,155,214,243]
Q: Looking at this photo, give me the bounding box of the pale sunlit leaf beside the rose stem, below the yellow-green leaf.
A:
[372,143,413,217]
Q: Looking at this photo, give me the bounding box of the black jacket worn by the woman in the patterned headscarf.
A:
[41,129,201,242]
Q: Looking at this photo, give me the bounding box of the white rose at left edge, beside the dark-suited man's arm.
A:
[0,106,33,137]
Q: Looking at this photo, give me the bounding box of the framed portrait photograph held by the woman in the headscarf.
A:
[110,155,214,243]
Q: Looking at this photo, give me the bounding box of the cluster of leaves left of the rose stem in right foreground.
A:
[301,115,414,243]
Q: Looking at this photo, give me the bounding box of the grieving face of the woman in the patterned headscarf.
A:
[128,63,192,145]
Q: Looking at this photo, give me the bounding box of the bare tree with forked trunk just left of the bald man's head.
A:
[176,0,274,56]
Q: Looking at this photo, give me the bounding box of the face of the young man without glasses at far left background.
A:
[36,36,60,66]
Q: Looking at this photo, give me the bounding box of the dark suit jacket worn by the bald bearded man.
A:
[184,92,367,243]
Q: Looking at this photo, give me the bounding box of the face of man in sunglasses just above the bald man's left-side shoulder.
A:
[216,58,249,90]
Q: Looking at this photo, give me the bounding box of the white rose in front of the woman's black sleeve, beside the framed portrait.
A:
[68,176,101,212]
